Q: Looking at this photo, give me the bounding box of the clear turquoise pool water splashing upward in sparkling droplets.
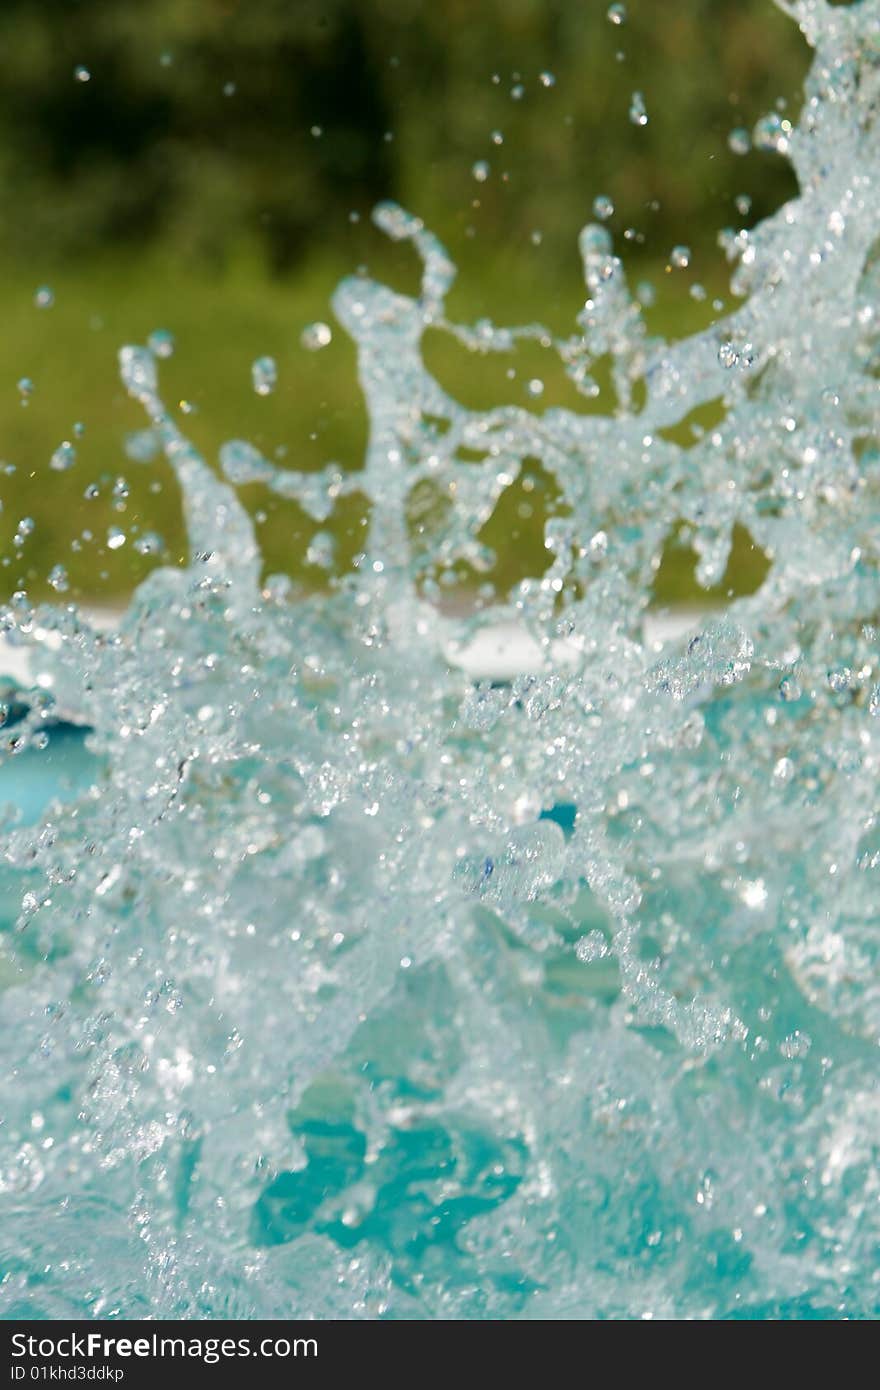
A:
[0,0,880,1318]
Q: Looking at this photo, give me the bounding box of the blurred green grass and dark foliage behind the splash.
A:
[0,0,809,599]
